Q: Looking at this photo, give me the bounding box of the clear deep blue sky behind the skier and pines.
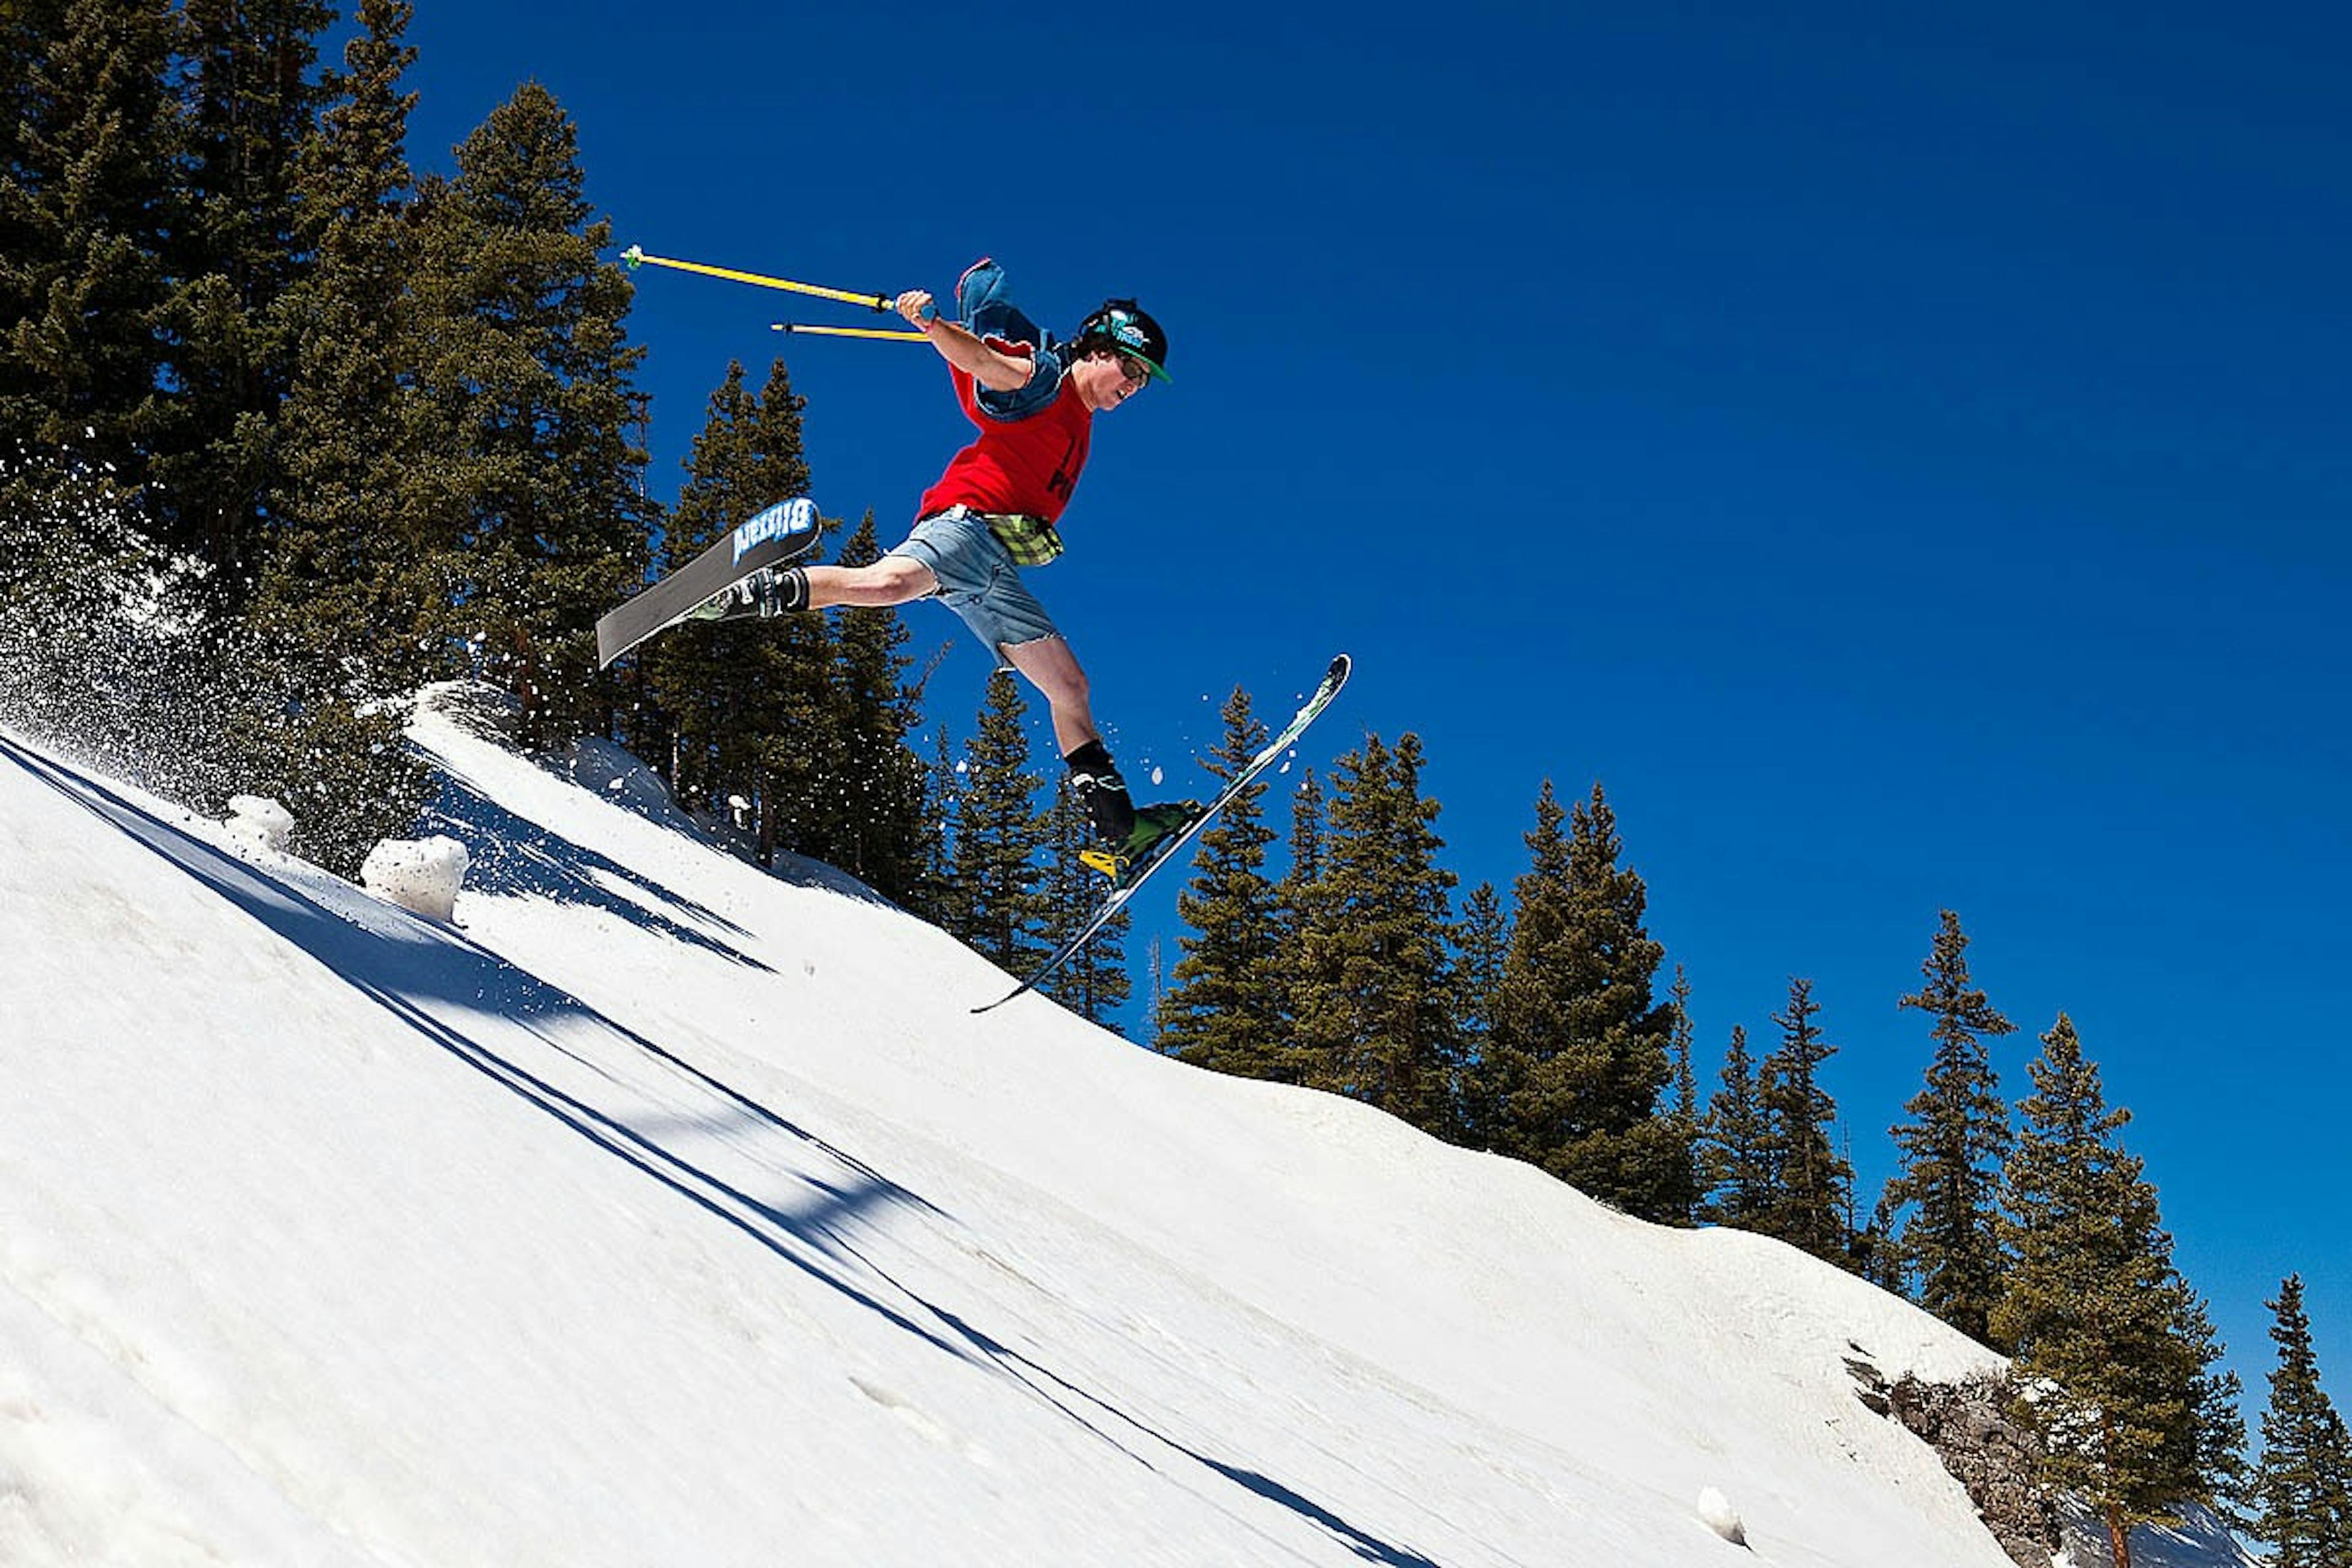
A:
[390,0,2352,1425]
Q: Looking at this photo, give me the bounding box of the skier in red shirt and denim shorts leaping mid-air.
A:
[696,258,1197,881]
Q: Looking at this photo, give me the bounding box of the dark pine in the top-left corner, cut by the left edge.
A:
[0,0,181,489]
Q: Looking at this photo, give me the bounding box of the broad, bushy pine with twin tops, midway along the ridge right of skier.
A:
[1489,783,1696,1220]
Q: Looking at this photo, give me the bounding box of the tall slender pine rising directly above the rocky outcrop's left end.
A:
[1887,910,2016,1340]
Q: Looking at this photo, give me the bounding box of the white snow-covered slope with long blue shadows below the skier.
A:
[0,707,2258,1568]
